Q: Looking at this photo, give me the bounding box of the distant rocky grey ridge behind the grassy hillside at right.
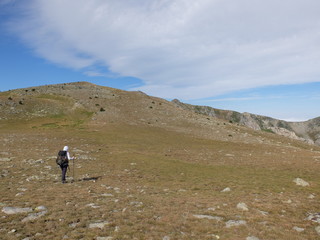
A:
[172,99,320,146]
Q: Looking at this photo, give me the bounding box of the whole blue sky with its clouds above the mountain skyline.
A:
[0,0,320,121]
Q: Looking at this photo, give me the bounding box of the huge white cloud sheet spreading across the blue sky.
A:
[6,0,320,99]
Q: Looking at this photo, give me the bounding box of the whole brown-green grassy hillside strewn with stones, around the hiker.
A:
[0,82,320,240]
